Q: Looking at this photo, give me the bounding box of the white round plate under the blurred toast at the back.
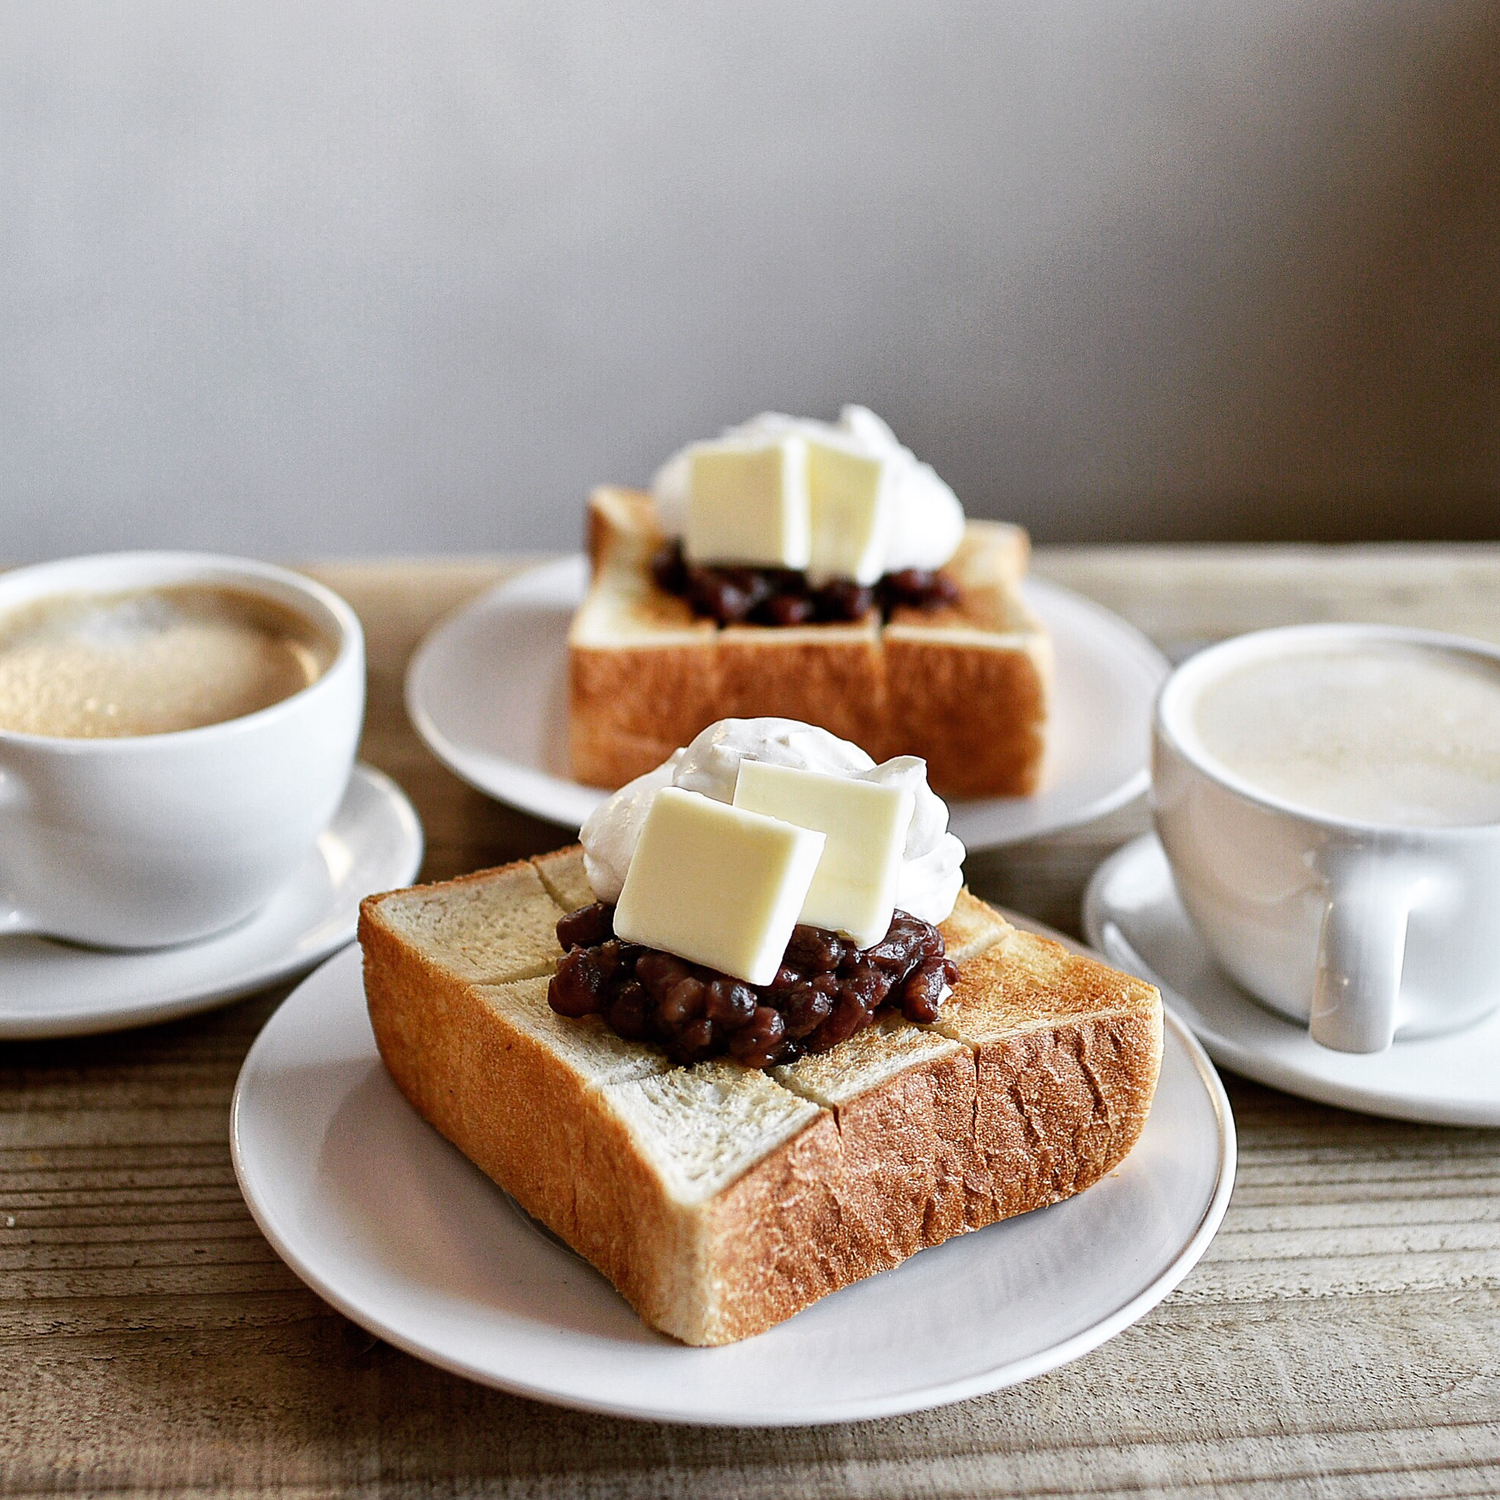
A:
[407,557,1169,849]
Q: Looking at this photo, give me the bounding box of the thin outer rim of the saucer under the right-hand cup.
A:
[1083,833,1500,1130]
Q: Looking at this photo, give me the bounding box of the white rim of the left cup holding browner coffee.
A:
[0,549,365,755]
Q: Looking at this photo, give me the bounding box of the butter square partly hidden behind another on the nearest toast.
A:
[735,761,917,948]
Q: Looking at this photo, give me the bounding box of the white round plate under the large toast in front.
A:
[231,906,1235,1427]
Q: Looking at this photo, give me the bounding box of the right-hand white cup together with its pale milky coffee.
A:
[1152,626,1500,1053]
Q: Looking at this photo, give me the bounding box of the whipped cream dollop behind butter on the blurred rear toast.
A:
[651,407,963,573]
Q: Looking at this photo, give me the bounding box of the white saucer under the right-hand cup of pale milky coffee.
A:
[1083,834,1500,1125]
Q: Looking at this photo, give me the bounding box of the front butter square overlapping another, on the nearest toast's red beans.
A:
[615,786,825,984]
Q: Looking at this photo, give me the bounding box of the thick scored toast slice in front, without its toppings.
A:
[360,846,1161,1344]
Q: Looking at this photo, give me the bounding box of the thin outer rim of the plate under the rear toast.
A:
[402,552,1172,852]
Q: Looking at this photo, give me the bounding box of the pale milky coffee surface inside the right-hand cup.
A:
[1191,641,1500,828]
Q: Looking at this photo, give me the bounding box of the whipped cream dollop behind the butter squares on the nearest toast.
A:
[579,719,965,926]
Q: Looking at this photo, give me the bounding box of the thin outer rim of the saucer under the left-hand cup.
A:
[0,761,426,1041]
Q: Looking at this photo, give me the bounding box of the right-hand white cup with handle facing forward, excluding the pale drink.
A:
[1152,626,1500,1052]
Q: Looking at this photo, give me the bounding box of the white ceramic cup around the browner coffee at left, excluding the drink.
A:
[0,552,365,948]
